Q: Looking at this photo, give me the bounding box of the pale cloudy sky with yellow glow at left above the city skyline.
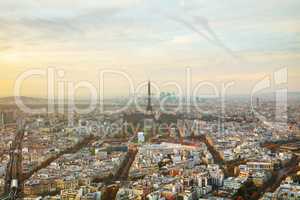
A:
[0,0,300,96]
